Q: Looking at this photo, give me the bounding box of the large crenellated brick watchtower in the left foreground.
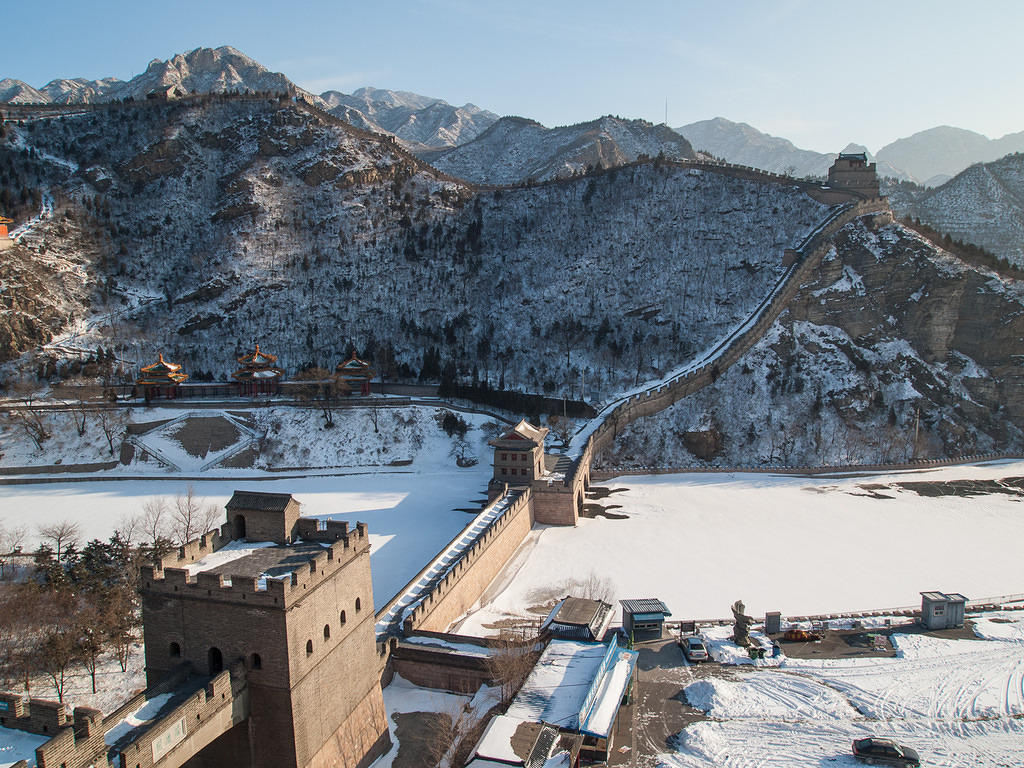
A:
[140,492,390,768]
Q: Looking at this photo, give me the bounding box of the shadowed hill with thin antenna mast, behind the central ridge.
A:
[420,116,695,184]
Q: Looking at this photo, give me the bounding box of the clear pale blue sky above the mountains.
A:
[0,0,1024,152]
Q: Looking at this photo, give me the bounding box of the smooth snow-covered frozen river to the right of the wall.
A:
[458,463,1024,634]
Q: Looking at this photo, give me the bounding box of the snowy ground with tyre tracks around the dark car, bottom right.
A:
[660,613,1024,768]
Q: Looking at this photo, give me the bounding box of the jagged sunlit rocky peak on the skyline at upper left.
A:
[0,45,315,103]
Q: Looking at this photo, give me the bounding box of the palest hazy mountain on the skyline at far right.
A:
[878,125,1024,185]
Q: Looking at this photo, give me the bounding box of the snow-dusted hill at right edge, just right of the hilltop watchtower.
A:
[898,154,1024,266]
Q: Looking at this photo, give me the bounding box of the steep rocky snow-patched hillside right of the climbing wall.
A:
[604,221,1024,467]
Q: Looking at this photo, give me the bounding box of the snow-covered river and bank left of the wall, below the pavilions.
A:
[0,407,490,605]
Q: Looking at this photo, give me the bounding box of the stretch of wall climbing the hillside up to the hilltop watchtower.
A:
[581,198,892,464]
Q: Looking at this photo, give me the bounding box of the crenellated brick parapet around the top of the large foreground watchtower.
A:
[140,520,370,607]
